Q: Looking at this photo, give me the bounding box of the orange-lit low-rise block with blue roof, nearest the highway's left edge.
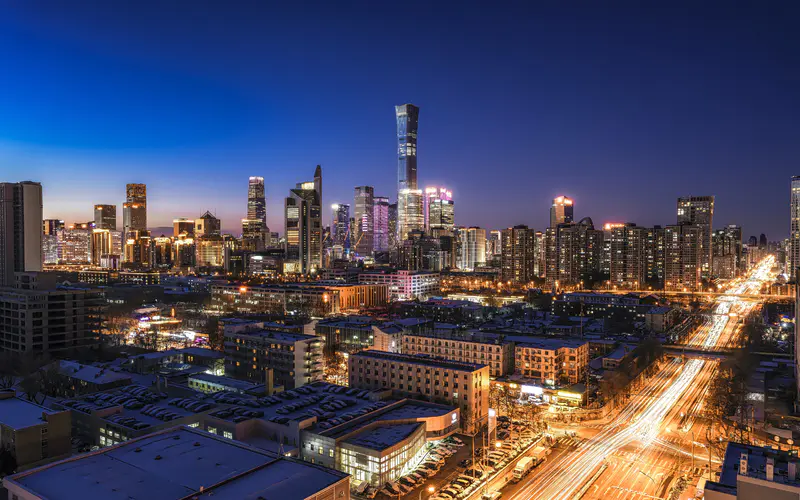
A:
[514,337,589,386]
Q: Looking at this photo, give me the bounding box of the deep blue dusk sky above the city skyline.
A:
[0,1,800,239]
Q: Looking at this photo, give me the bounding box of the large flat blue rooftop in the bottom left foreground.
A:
[6,427,347,500]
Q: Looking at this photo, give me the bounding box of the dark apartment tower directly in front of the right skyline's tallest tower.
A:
[664,224,704,291]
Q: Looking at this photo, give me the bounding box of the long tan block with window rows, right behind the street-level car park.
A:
[348,350,490,431]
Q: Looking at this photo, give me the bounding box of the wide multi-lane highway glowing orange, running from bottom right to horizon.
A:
[508,257,774,500]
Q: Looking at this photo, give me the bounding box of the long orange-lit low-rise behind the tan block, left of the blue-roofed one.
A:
[402,331,514,377]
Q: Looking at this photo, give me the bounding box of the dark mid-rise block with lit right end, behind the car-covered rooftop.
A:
[224,323,323,390]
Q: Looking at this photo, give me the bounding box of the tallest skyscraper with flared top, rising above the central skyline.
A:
[395,104,425,241]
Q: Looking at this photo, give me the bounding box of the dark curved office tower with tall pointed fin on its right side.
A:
[284,165,322,274]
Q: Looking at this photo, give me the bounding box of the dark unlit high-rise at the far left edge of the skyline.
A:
[0,181,43,286]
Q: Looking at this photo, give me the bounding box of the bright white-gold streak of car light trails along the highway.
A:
[516,256,774,500]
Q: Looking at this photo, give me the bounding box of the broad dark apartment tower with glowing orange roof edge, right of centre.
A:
[603,222,647,290]
